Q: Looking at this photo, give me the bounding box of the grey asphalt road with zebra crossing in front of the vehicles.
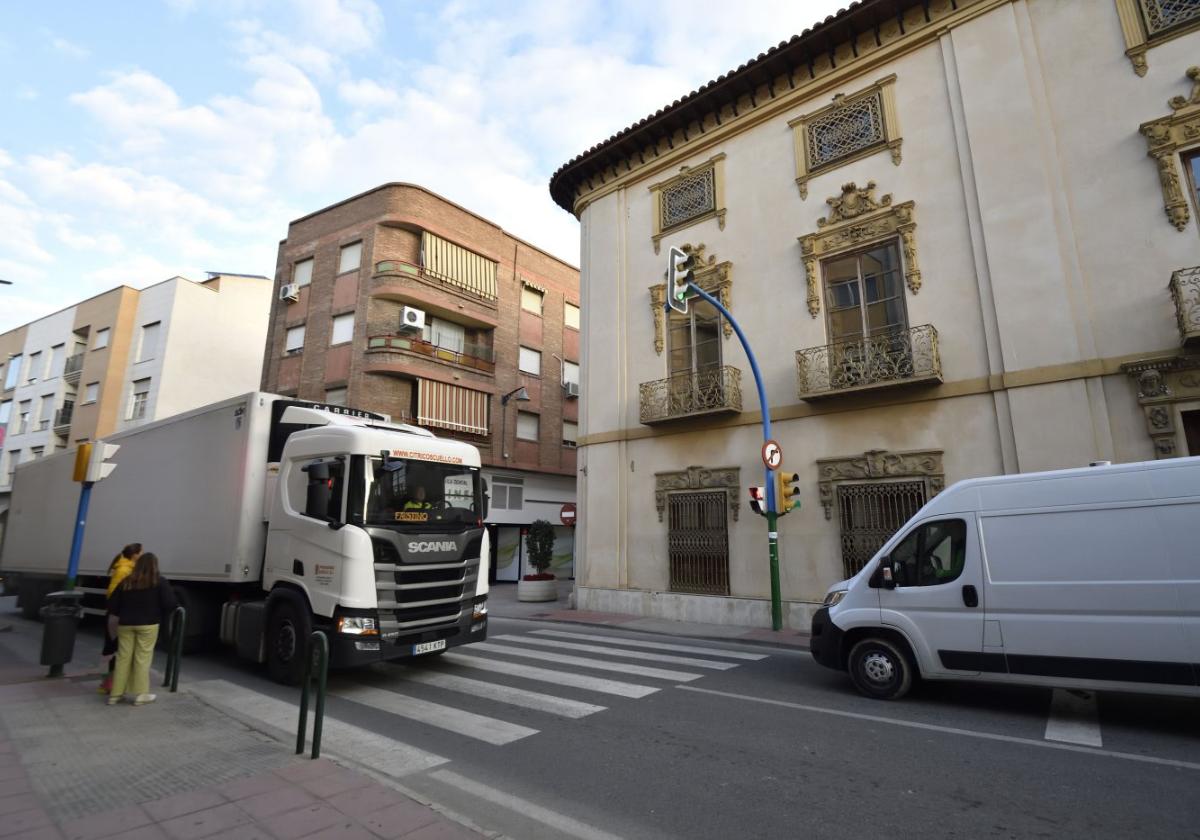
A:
[0,599,1200,840]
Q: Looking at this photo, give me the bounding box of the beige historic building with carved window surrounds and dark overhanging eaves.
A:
[551,0,1200,628]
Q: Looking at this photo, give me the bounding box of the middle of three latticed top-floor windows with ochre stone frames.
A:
[787,76,901,198]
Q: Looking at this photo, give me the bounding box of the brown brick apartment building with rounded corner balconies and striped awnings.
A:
[263,184,580,581]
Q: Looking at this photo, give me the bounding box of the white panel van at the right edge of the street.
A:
[811,457,1200,700]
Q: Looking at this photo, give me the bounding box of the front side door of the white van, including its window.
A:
[880,514,984,674]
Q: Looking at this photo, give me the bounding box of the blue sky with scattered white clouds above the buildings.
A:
[0,0,847,332]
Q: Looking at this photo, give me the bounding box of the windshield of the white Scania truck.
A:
[365,458,480,527]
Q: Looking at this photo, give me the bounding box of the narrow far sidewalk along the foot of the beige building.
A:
[487,581,809,650]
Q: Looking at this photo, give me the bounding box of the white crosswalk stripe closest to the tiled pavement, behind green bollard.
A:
[187,679,450,776]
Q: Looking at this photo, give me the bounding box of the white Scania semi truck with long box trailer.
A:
[0,391,490,684]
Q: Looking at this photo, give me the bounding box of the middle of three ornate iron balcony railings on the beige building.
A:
[796,324,942,400]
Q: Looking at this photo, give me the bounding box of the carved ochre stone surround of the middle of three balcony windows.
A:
[797,181,920,318]
